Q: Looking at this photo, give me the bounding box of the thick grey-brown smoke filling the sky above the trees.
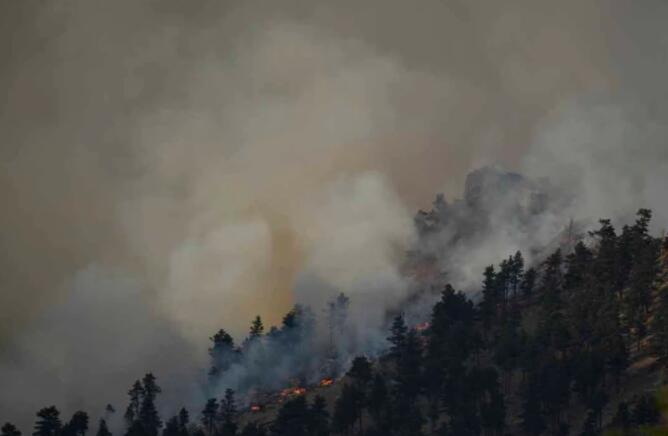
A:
[0,0,668,426]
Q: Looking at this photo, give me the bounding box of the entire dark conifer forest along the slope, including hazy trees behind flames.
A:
[2,209,668,436]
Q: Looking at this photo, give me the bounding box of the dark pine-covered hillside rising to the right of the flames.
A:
[231,211,668,435]
